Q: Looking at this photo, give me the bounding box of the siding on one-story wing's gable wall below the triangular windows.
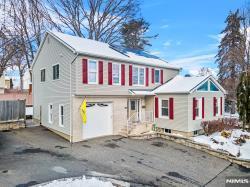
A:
[188,91,224,132]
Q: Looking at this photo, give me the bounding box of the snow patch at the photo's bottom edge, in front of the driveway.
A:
[36,176,113,187]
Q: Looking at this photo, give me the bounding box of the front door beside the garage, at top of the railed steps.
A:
[129,99,140,122]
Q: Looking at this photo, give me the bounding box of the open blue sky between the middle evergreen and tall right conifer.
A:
[141,0,246,75]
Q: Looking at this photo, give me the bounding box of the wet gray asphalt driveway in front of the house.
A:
[0,127,250,187]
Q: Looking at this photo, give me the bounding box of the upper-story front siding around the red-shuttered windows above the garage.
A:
[74,56,179,95]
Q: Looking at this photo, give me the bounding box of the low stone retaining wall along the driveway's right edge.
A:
[129,132,250,168]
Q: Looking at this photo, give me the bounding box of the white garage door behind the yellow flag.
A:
[83,103,113,139]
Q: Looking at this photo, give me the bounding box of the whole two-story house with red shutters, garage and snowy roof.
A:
[32,32,225,142]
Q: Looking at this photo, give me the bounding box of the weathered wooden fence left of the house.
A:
[0,100,25,123]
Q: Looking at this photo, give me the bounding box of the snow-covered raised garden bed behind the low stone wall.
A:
[193,129,250,159]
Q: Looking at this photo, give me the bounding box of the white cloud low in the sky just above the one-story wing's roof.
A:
[169,53,218,76]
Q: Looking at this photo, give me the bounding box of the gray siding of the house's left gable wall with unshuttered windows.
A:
[32,35,75,134]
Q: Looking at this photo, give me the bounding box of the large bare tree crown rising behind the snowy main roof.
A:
[48,0,139,44]
